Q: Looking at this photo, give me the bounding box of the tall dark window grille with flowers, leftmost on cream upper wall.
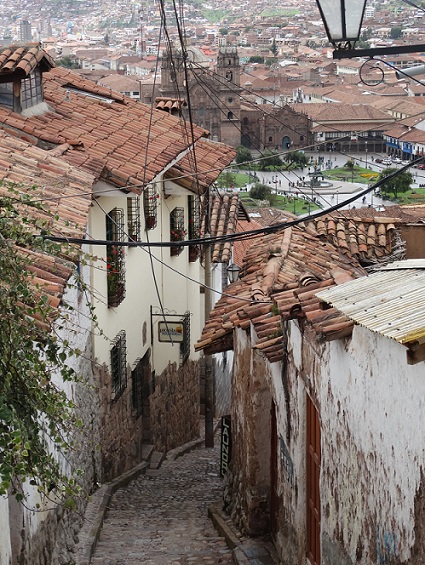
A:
[106,208,125,307]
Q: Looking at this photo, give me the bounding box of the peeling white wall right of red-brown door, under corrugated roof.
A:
[317,326,425,563]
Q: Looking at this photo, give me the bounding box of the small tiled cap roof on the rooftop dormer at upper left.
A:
[0,44,55,76]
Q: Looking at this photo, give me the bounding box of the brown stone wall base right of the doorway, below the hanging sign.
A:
[150,361,200,453]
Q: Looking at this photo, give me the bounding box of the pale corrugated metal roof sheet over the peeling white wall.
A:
[317,266,425,344]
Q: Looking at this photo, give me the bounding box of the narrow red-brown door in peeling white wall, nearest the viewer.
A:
[307,395,320,565]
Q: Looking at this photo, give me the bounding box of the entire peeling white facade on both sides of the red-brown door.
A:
[282,322,425,565]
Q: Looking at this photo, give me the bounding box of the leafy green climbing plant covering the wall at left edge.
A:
[0,185,88,507]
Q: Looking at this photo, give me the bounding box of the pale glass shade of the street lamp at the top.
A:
[316,0,366,44]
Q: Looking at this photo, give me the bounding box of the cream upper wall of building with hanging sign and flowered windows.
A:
[89,184,203,373]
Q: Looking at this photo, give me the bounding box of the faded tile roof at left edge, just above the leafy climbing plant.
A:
[0,131,94,316]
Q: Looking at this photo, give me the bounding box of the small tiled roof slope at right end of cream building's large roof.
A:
[165,139,236,194]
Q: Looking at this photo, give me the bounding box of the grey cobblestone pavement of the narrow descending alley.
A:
[91,438,233,565]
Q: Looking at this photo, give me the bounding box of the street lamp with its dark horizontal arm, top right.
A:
[316,0,425,59]
